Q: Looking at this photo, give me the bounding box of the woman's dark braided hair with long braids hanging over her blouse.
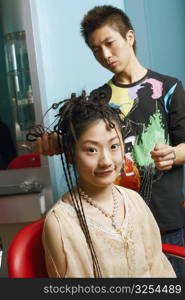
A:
[54,91,122,277]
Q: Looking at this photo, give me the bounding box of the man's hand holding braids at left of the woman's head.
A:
[36,132,62,156]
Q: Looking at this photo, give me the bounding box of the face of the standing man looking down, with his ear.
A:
[89,25,134,74]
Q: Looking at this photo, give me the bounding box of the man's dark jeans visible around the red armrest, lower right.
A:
[161,227,185,278]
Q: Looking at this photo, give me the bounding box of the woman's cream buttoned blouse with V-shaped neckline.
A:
[43,186,176,278]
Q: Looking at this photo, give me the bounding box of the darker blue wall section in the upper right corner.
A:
[145,0,185,87]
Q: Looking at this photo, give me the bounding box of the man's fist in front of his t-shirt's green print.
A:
[150,143,176,171]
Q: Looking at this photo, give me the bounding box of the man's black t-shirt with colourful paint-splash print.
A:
[92,70,185,230]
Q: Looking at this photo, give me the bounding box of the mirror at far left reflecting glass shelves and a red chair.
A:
[0,0,40,170]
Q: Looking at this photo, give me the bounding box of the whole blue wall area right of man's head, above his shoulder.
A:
[125,0,185,87]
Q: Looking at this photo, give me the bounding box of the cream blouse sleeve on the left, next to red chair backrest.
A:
[42,211,66,278]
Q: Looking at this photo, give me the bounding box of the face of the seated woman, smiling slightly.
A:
[75,120,124,188]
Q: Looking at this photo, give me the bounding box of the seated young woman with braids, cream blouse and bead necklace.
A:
[43,93,175,278]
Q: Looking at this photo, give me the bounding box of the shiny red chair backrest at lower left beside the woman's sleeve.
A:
[7,219,48,278]
